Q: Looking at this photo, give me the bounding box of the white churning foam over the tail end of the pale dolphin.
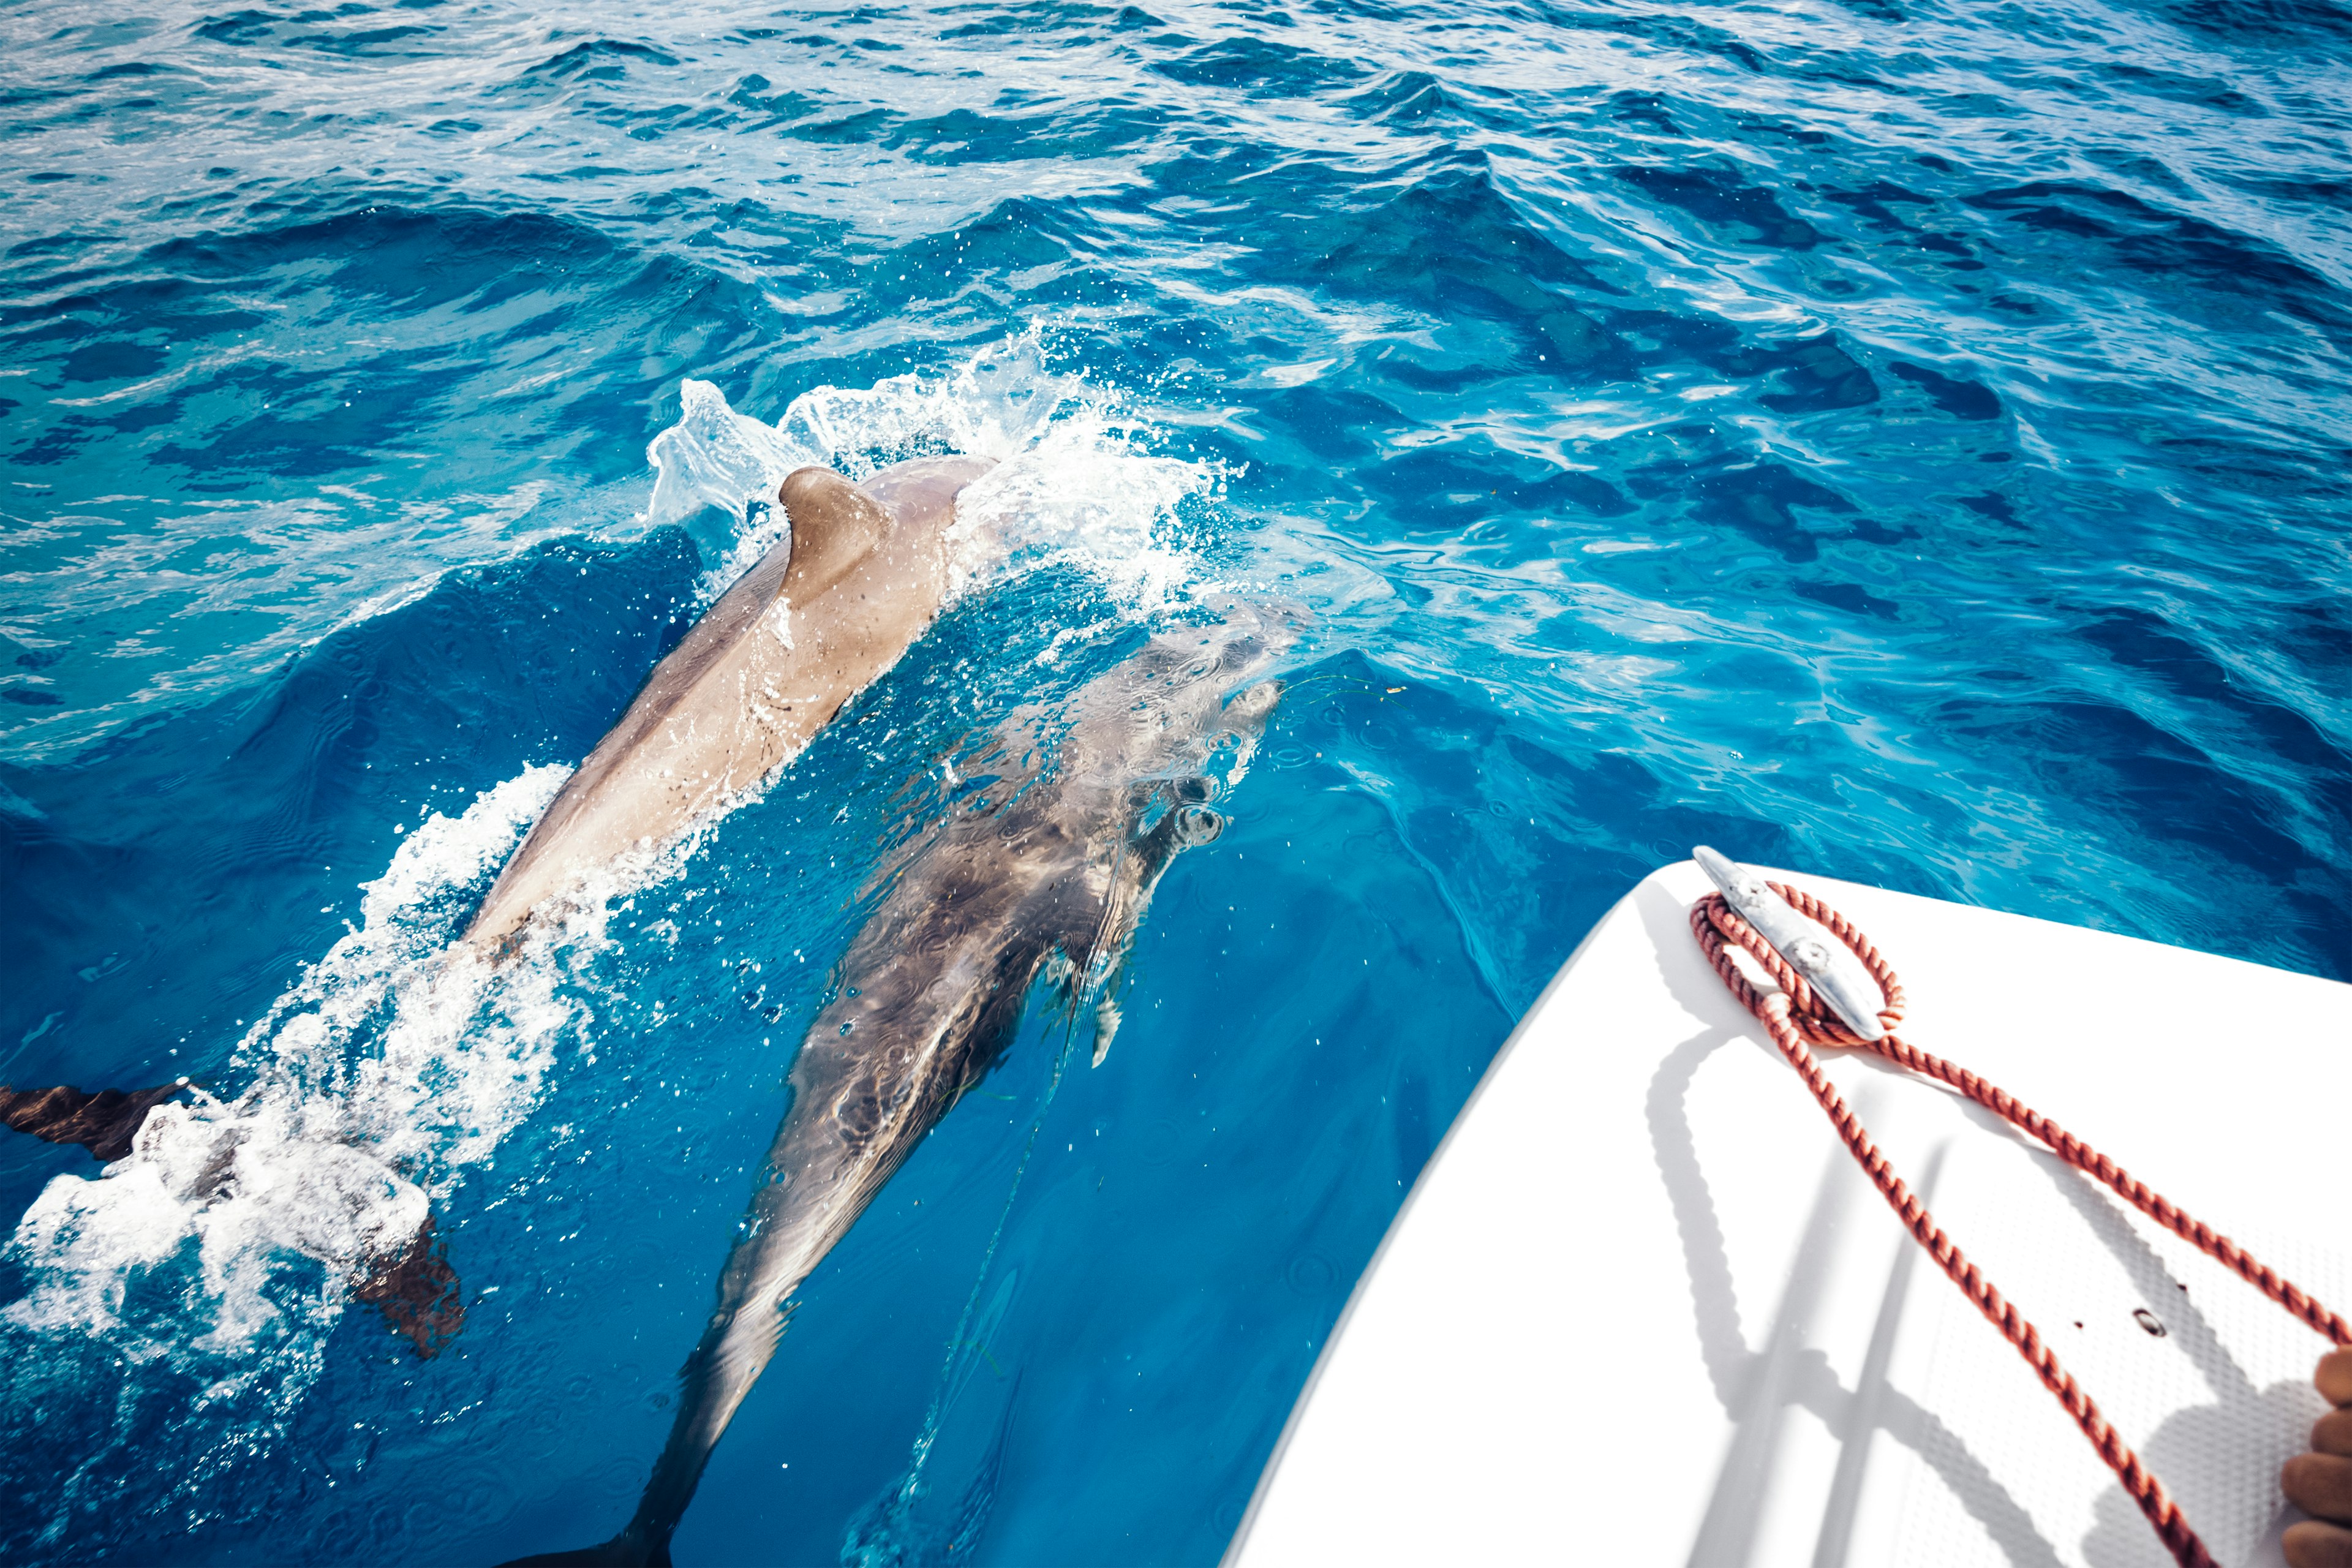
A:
[5,766,590,1363]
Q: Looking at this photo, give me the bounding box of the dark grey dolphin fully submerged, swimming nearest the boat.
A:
[513,604,1296,1568]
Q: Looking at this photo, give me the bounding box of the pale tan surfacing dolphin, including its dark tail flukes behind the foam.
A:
[0,458,995,1357]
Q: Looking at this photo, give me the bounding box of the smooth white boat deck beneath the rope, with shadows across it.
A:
[1227,863,2352,1568]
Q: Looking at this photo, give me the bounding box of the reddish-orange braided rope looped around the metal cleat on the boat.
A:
[1691,881,2352,1568]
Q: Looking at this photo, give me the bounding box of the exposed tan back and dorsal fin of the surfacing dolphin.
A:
[463,458,995,957]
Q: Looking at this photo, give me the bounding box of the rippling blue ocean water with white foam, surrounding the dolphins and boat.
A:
[0,0,2352,1566]
